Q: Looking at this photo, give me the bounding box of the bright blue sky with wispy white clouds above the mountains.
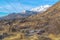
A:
[0,0,58,17]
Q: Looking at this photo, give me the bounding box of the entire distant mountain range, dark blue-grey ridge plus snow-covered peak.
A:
[0,5,50,19]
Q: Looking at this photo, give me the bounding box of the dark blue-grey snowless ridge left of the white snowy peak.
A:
[0,10,37,19]
